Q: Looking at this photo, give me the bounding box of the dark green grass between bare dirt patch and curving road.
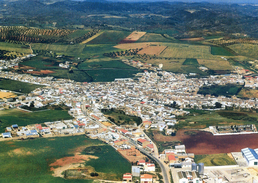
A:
[83,145,131,180]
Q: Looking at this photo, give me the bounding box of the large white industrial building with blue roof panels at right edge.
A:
[241,148,258,166]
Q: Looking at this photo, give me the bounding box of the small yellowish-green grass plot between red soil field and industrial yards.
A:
[194,154,236,166]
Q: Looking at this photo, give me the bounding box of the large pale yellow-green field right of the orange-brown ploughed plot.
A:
[160,43,217,60]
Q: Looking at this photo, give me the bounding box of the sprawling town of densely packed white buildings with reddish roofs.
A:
[0,55,258,183]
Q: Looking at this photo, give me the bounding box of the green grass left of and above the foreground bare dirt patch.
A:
[0,136,104,183]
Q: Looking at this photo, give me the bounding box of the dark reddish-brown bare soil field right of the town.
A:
[155,130,258,154]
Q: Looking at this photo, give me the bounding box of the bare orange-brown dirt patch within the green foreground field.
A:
[49,154,98,177]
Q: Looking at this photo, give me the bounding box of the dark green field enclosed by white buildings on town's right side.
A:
[198,84,243,97]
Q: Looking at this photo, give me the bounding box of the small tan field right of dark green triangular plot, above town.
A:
[198,59,232,70]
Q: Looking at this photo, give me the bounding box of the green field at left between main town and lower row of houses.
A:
[0,109,73,132]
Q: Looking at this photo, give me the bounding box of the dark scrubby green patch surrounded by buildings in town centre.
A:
[101,108,142,125]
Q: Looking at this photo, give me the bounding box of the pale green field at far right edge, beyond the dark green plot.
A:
[229,44,258,59]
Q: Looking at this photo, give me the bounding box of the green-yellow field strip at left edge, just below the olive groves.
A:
[0,42,31,54]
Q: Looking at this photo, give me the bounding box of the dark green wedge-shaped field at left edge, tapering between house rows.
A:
[0,78,44,93]
